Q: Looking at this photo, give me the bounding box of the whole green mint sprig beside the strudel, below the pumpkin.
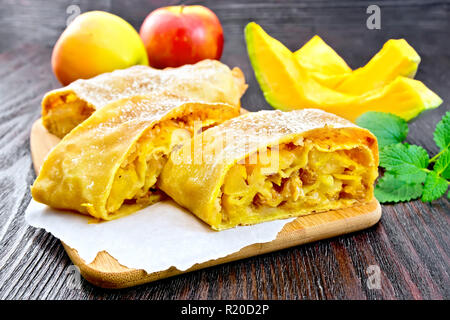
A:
[356,111,450,202]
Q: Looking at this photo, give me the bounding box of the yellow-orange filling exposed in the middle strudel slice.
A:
[106,112,222,216]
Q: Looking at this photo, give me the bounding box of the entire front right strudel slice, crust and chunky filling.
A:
[158,109,378,230]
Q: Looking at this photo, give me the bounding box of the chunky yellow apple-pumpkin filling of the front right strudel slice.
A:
[218,140,376,227]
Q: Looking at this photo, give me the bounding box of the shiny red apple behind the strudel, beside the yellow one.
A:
[139,6,223,68]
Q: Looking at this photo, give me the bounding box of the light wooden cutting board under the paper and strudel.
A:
[30,119,381,288]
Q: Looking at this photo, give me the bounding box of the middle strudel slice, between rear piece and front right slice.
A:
[31,94,238,220]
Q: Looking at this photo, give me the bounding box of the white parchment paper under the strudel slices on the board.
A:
[25,200,294,273]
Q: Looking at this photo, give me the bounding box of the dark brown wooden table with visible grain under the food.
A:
[0,0,450,299]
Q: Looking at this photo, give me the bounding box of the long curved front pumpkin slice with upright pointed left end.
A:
[245,22,442,121]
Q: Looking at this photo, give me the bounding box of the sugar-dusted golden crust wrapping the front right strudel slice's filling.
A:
[158,109,378,230]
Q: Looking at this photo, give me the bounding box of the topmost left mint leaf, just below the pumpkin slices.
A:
[356,111,408,150]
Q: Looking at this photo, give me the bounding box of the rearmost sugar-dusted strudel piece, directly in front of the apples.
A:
[42,60,247,138]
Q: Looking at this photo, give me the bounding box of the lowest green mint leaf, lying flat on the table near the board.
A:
[375,174,423,203]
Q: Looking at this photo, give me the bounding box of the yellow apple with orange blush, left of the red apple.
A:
[52,11,148,85]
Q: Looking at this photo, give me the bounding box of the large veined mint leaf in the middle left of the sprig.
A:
[380,143,430,183]
